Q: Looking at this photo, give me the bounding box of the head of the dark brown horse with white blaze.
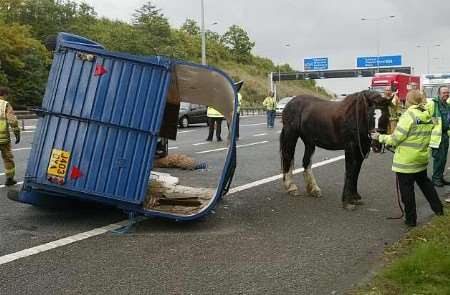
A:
[361,90,391,153]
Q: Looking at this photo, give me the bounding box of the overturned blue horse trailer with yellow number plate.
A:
[10,33,237,220]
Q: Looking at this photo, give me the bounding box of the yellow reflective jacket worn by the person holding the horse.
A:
[378,105,434,173]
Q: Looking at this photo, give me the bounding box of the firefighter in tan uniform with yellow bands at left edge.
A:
[0,87,20,186]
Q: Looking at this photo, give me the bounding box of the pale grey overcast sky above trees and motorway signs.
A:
[86,0,450,93]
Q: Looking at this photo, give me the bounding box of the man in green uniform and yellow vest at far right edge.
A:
[428,86,450,187]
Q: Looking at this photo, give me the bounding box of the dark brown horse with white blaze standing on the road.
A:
[280,90,389,210]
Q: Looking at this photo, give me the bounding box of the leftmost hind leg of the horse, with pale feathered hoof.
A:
[280,126,300,196]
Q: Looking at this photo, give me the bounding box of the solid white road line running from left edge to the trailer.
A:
[0,220,128,265]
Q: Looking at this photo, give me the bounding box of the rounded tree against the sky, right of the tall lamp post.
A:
[222,25,255,63]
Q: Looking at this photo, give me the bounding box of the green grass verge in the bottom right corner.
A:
[351,206,450,295]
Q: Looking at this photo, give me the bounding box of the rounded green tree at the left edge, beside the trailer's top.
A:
[0,22,49,106]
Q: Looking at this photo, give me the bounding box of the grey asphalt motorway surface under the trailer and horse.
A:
[0,117,445,294]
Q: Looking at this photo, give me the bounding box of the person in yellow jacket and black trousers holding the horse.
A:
[372,90,444,226]
